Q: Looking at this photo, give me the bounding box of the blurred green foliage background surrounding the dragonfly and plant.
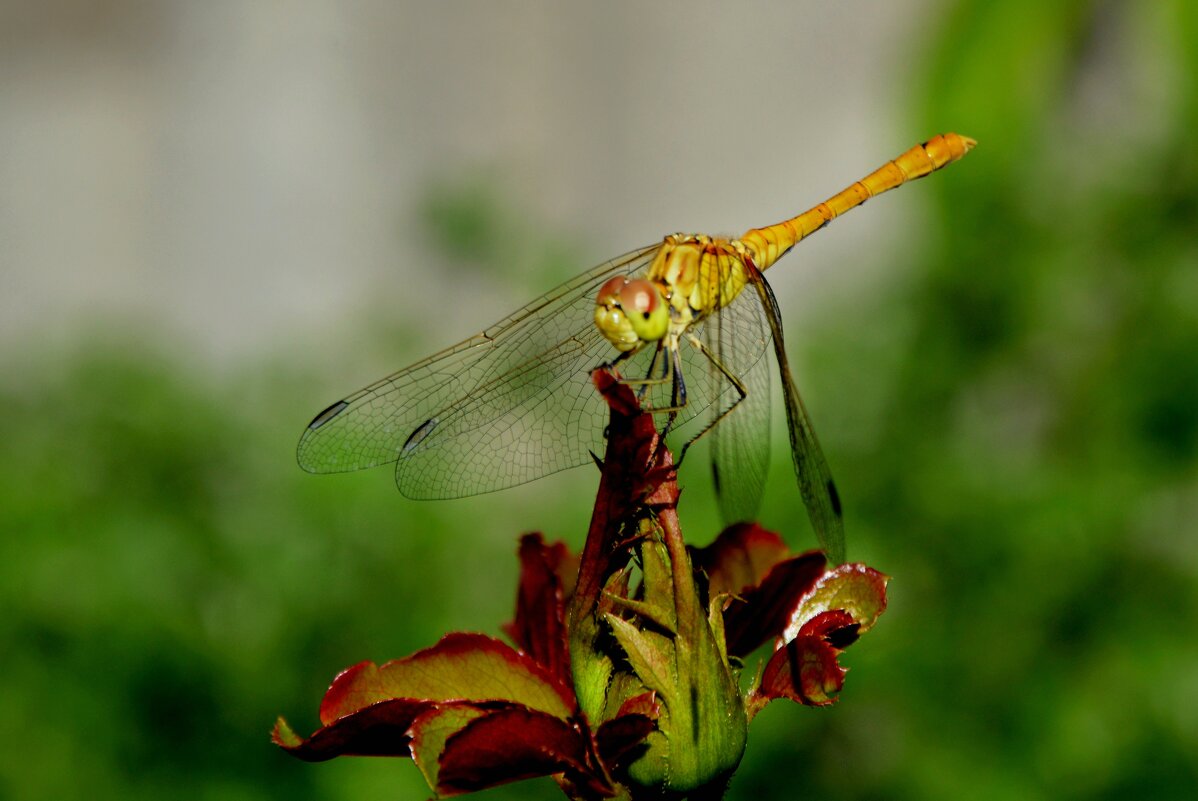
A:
[0,0,1198,801]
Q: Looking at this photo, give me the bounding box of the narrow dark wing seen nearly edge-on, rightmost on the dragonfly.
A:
[745,267,845,565]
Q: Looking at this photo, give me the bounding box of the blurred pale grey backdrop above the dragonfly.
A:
[0,0,948,361]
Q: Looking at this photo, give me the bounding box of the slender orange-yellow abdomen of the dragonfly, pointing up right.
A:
[740,133,978,269]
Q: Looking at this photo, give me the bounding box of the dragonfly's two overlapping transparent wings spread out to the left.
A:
[297,244,764,499]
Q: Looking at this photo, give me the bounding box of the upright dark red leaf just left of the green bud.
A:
[503,534,579,686]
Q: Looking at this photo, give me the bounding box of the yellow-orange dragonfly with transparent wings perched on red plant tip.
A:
[297,133,975,564]
